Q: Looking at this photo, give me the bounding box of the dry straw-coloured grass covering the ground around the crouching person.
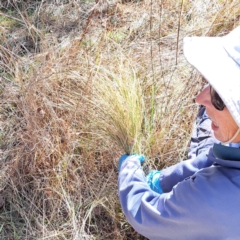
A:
[0,0,240,239]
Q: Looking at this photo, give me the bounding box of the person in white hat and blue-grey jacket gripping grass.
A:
[118,27,240,240]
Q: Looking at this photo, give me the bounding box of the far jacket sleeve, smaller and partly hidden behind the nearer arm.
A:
[160,149,213,192]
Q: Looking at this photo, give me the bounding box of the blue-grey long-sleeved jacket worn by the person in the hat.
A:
[118,144,240,240]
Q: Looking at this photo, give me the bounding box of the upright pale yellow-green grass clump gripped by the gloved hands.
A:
[94,56,145,154]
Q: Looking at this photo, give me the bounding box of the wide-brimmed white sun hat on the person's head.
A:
[183,27,240,127]
